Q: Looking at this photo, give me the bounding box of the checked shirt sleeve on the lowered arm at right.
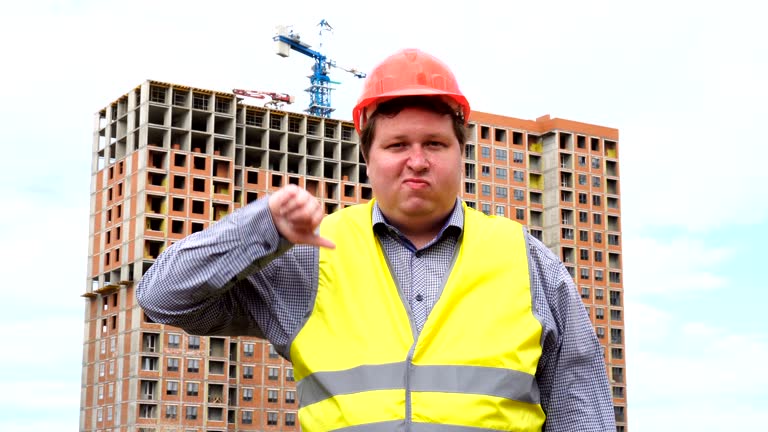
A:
[528,236,616,432]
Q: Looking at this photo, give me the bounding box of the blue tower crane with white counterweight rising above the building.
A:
[272,20,366,117]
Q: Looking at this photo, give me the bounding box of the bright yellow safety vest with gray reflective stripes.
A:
[290,202,545,432]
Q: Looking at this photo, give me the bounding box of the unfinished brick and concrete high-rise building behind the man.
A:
[80,81,627,432]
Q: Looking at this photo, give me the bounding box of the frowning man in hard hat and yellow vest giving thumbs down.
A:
[137,49,615,432]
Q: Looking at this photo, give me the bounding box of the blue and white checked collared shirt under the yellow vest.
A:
[136,199,616,432]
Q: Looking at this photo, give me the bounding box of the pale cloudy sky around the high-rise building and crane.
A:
[0,0,768,432]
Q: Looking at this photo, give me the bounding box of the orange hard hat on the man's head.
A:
[352,48,470,133]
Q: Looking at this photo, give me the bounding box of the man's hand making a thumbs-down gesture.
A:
[269,184,336,249]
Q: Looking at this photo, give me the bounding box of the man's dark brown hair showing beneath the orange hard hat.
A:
[360,96,467,162]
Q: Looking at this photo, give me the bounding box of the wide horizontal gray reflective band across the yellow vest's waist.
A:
[298,363,539,407]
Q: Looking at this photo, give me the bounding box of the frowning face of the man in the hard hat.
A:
[367,108,461,230]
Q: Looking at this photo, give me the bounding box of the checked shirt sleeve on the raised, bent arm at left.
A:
[136,198,317,352]
